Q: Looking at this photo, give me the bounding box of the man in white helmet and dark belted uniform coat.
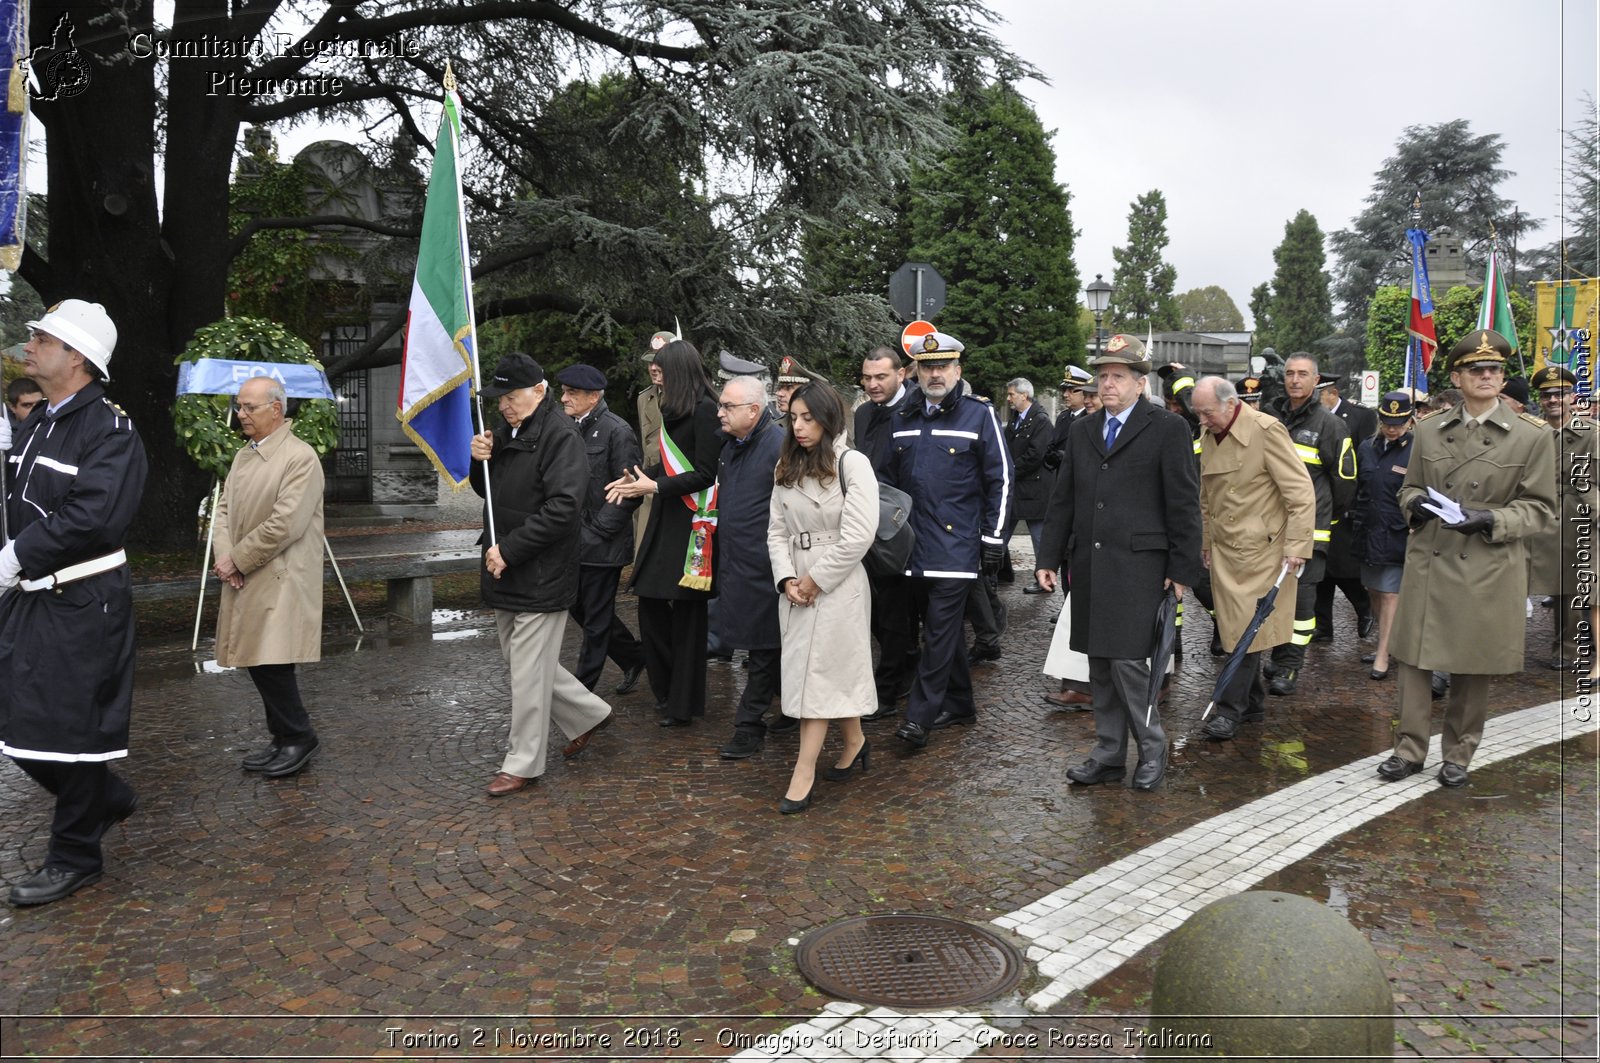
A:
[0,299,149,906]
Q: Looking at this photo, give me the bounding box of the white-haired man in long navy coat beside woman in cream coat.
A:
[717,376,787,760]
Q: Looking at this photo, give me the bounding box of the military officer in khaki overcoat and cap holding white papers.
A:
[1378,328,1555,786]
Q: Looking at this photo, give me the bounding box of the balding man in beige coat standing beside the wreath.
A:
[214,376,323,778]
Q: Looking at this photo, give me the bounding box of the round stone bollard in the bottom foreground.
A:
[1142,890,1395,1063]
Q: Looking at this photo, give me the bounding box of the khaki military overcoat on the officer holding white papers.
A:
[1389,402,1557,676]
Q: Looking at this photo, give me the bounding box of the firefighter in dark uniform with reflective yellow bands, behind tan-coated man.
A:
[1264,351,1355,695]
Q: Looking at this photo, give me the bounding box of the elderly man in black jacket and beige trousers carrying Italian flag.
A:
[472,354,611,797]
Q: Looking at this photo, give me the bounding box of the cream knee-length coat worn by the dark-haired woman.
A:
[766,437,878,719]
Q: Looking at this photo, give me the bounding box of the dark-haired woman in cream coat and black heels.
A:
[766,383,878,815]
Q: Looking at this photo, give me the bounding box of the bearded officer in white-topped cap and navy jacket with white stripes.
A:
[883,331,1011,749]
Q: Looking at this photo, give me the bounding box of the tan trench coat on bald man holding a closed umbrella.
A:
[1200,407,1317,653]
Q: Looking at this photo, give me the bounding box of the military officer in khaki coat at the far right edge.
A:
[1528,365,1600,677]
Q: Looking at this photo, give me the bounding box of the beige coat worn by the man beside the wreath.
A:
[216,421,323,668]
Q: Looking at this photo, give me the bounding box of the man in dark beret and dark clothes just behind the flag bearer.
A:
[555,363,645,697]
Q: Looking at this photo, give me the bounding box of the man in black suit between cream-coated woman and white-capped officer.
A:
[856,347,920,720]
